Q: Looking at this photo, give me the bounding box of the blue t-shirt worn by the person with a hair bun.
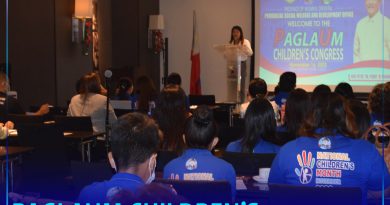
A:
[164,149,236,197]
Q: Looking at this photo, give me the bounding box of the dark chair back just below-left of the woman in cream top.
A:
[54,115,93,132]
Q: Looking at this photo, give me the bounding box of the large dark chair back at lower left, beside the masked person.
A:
[18,123,69,195]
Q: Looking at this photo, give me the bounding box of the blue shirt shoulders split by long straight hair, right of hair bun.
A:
[226,140,280,154]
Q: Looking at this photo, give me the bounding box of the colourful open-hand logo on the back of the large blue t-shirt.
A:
[295,150,316,184]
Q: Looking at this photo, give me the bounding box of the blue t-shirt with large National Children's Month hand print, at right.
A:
[268,135,390,199]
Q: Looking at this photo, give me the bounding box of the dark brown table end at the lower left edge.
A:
[0,146,34,191]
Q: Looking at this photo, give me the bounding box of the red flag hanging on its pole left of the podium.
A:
[190,11,202,95]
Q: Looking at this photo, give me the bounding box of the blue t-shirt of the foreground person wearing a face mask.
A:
[77,173,145,204]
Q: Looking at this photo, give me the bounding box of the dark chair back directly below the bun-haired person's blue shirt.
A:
[155,179,232,204]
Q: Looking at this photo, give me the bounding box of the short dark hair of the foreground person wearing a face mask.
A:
[110,113,160,169]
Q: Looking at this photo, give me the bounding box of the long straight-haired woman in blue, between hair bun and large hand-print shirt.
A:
[226,98,279,153]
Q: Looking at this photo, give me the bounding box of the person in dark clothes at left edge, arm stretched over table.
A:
[0,72,49,122]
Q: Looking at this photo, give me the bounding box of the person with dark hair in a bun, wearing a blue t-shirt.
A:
[164,106,236,196]
